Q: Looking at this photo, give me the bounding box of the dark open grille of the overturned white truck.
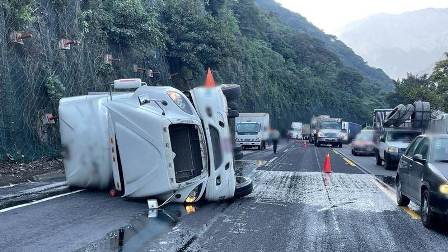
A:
[169,124,203,183]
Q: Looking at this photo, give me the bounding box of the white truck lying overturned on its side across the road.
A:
[59,79,253,203]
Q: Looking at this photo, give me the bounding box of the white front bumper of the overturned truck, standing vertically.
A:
[190,87,236,200]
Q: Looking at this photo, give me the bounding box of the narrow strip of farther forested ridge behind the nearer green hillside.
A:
[256,0,393,91]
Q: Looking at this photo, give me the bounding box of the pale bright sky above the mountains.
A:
[275,0,448,35]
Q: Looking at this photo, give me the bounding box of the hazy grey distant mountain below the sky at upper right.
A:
[340,9,448,79]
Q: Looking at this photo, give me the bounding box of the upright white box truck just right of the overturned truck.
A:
[235,113,270,150]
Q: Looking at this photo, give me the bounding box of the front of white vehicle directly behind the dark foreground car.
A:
[375,128,421,170]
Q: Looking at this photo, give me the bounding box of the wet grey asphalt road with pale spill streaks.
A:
[0,141,448,251]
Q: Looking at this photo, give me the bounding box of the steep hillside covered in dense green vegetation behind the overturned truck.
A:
[0,0,390,160]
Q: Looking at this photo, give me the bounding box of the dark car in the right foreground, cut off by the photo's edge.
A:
[395,134,448,228]
